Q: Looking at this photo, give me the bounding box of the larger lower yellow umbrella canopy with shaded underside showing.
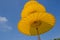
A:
[18,13,55,36]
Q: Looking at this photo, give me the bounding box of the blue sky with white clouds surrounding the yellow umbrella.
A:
[0,0,60,40]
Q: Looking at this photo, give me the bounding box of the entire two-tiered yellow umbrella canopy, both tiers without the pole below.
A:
[18,0,55,39]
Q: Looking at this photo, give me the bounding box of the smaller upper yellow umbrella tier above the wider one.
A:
[21,1,46,18]
